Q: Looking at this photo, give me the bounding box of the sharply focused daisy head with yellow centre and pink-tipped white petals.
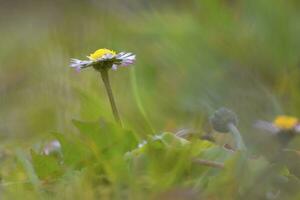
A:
[70,49,136,71]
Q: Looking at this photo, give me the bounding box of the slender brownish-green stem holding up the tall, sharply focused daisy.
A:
[100,68,122,126]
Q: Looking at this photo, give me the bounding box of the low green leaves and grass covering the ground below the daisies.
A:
[5,120,300,200]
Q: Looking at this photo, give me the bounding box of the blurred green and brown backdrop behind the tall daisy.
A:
[0,0,300,148]
